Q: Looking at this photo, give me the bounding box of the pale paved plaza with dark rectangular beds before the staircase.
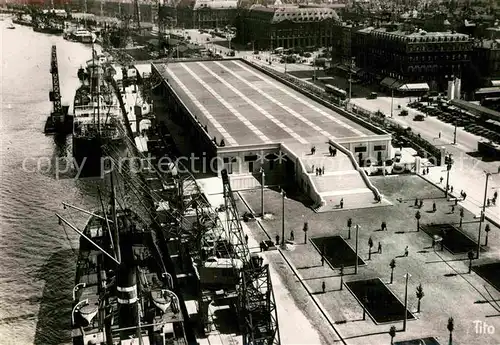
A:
[238,175,500,345]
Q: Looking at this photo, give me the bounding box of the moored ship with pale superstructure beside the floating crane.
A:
[73,50,125,177]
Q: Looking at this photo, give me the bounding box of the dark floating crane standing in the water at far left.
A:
[44,45,73,134]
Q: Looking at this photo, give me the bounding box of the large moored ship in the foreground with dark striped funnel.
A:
[57,175,187,345]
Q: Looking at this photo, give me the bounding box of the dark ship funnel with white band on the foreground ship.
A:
[116,264,138,328]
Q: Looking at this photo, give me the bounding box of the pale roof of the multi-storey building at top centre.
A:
[250,5,340,23]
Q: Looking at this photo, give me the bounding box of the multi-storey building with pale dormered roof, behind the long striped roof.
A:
[236,5,339,49]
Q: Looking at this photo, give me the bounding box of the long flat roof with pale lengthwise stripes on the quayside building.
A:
[154,60,373,147]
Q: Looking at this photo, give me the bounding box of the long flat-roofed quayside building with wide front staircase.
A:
[151,59,392,210]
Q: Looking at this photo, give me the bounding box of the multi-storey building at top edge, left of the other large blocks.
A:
[160,0,238,29]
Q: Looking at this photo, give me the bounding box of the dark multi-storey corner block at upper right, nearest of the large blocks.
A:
[352,27,473,89]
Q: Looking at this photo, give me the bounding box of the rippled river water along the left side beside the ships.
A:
[0,20,111,345]
